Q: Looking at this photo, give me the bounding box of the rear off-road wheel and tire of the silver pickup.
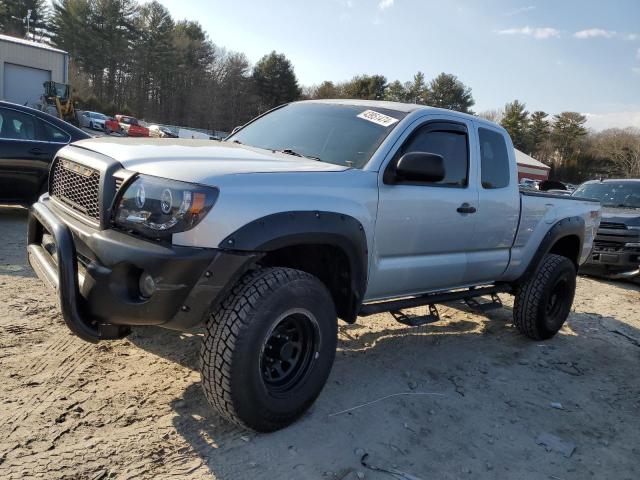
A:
[513,254,576,340]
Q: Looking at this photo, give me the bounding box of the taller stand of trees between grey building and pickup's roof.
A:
[50,0,300,130]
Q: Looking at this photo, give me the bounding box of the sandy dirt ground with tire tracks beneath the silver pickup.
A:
[0,204,640,480]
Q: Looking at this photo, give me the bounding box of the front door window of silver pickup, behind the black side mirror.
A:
[398,125,469,188]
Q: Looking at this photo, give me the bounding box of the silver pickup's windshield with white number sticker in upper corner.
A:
[227,103,406,168]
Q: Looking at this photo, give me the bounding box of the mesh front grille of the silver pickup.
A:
[49,158,100,221]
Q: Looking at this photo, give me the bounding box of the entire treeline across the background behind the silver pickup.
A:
[0,0,640,182]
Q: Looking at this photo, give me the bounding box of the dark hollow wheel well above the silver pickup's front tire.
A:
[260,245,357,323]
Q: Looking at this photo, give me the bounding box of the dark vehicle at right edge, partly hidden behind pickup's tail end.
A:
[573,179,640,279]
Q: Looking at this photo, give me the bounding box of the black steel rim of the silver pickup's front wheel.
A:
[260,310,320,395]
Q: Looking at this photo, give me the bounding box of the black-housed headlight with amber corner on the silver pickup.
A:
[114,175,218,238]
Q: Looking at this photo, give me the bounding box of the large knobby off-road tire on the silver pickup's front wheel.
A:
[200,268,337,432]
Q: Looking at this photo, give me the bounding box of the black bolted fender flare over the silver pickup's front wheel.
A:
[219,211,369,320]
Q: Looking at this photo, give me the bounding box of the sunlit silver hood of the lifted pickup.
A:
[73,137,348,182]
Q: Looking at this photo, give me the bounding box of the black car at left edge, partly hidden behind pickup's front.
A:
[0,101,90,203]
